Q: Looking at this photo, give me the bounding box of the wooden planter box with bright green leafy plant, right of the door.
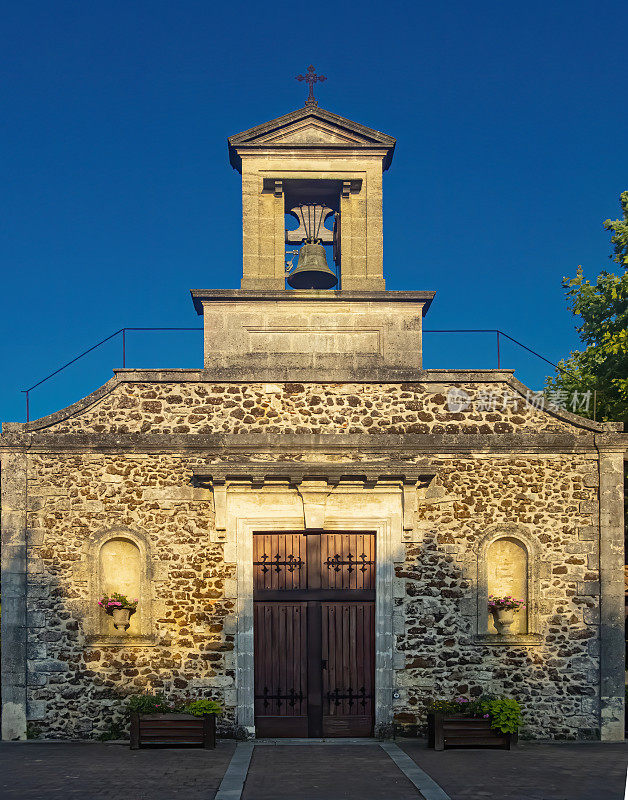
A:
[427,695,521,750]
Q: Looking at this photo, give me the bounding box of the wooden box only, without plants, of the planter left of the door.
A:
[131,714,216,750]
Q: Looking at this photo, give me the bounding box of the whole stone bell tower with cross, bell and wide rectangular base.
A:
[192,76,434,381]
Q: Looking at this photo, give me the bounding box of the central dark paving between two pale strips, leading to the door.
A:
[242,742,421,800]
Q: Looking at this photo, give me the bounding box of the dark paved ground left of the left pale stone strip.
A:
[0,741,235,800]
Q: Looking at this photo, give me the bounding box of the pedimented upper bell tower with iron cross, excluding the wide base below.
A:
[228,67,395,291]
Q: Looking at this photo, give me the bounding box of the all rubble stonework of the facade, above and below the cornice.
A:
[2,383,620,738]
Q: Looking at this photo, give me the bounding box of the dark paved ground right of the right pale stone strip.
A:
[397,740,628,800]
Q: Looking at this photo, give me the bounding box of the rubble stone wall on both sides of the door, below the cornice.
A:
[24,456,599,737]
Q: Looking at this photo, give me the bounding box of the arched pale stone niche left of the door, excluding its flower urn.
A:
[85,527,154,645]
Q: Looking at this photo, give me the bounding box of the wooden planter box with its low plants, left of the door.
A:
[128,694,222,750]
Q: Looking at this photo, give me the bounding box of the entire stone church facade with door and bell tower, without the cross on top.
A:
[0,104,627,741]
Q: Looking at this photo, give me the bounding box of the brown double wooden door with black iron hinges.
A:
[253,531,375,737]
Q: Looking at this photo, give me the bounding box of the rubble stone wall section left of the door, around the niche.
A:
[23,455,235,737]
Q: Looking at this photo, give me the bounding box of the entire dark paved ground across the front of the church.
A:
[0,740,628,800]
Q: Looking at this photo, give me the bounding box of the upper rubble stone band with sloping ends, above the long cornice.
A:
[31,382,581,434]
